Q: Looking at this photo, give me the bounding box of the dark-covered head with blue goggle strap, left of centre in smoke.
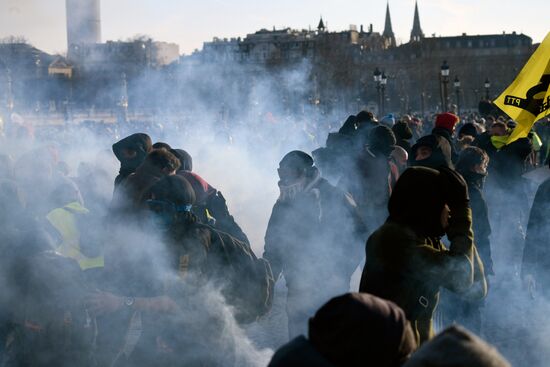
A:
[146,175,195,230]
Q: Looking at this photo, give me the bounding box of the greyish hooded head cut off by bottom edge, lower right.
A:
[403,326,510,367]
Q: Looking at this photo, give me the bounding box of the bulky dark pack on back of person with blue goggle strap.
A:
[167,222,274,322]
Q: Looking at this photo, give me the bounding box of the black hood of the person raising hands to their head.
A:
[388,167,446,236]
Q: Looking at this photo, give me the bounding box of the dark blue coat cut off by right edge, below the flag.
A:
[522,179,550,294]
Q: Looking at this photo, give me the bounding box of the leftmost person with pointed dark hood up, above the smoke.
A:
[113,133,153,191]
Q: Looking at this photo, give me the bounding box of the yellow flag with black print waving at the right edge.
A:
[494,33,550,143]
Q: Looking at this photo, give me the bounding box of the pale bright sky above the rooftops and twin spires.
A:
[0,0,550,53]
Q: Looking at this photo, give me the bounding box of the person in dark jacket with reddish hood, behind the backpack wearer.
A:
[170,149,250,244]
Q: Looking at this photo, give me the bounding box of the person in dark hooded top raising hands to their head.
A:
[360,167,487,343]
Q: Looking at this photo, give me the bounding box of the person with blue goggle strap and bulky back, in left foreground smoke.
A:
[92,175,273,366]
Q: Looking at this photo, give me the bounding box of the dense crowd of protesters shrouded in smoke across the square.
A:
[0,110,550,367]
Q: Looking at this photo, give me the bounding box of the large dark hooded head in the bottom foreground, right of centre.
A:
[309,293,417,367]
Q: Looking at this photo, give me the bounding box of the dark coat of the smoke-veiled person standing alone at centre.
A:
[263,178,366,295]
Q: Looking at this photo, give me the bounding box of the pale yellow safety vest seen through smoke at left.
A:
[46,201,105,270]
